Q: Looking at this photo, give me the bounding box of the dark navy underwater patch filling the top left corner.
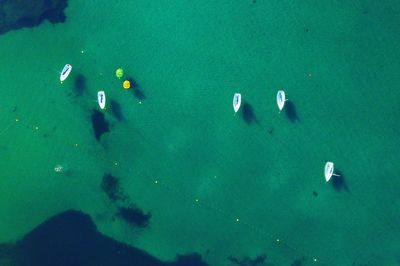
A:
[0,0,68,34]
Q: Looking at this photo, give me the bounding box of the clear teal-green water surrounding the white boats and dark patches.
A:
[0,0,400,265]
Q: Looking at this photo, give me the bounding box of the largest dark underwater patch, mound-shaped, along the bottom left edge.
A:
[0,210,207,266]
